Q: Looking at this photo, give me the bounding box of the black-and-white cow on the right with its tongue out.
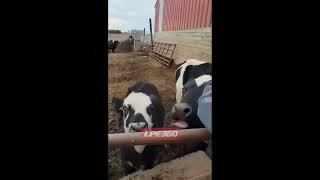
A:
[168,59,212,152]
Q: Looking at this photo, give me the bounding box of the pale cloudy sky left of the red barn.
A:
[108,0,156,34]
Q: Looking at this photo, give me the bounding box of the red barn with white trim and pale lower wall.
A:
[154,0,212,64]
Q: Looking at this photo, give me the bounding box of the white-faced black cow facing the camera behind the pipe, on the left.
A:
[112,81,165,175]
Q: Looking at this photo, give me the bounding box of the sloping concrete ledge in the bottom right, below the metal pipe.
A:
[121,151,212,180]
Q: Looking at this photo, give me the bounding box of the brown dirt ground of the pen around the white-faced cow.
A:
[108,53,188,180]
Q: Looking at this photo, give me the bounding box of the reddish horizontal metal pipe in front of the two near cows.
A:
[108,128,209,147]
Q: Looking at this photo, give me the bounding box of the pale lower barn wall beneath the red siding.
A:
[155,28,212,64]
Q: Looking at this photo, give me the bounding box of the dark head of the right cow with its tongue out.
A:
[167,75,211,129]
